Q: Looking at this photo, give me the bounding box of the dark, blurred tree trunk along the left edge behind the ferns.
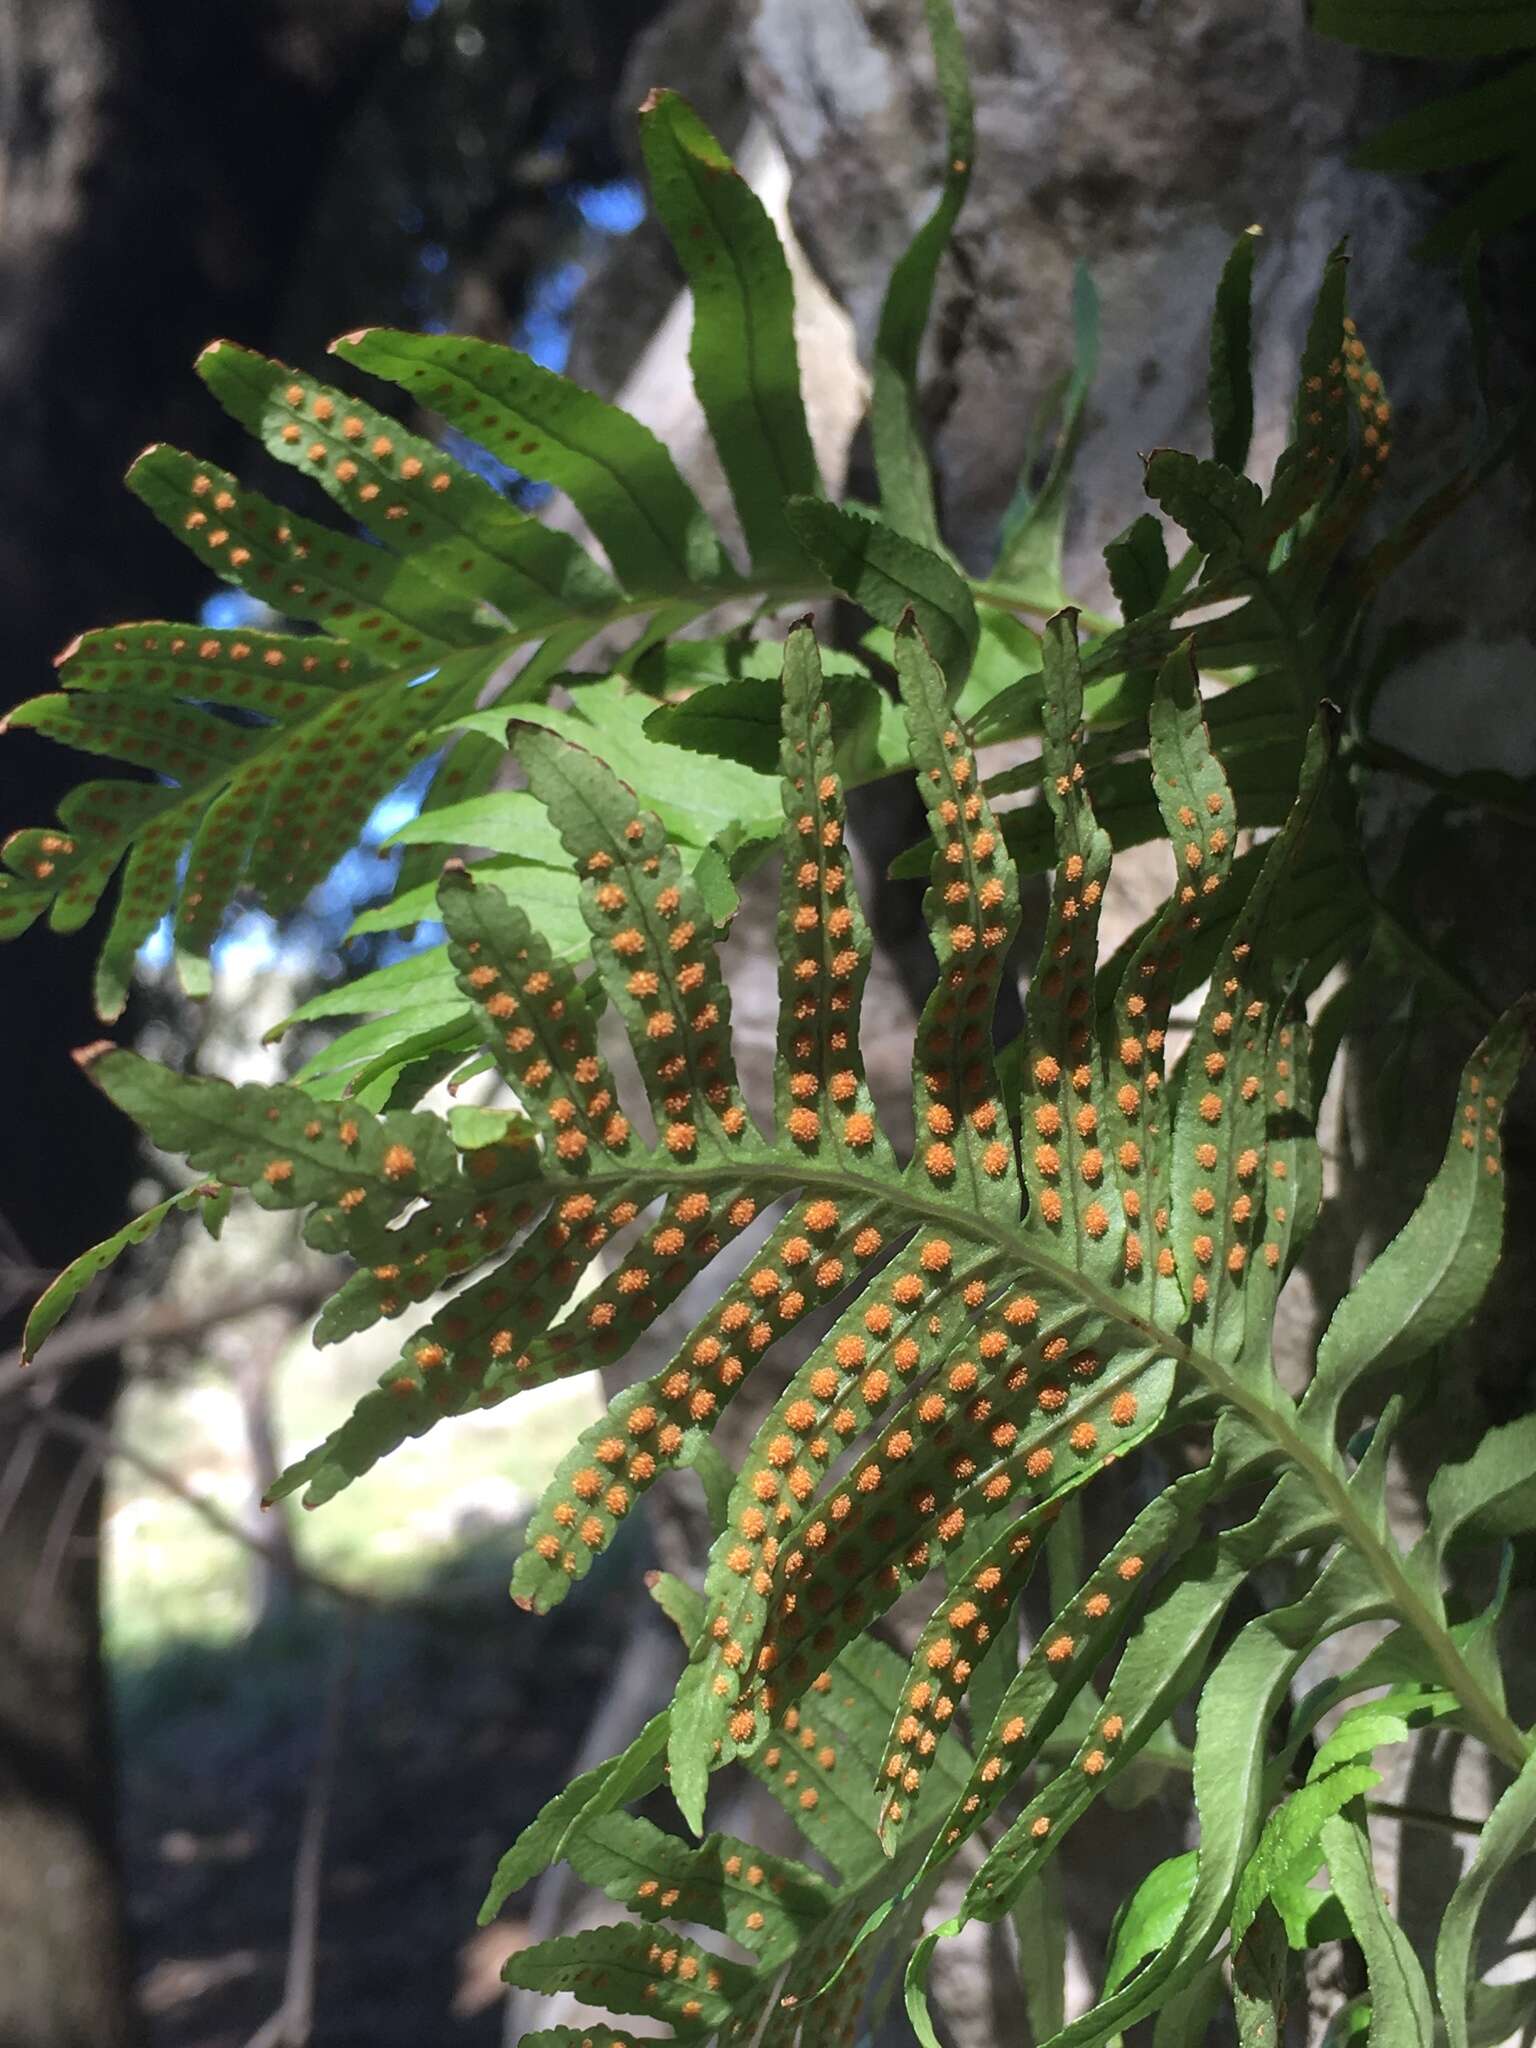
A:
[0,0,403,2048]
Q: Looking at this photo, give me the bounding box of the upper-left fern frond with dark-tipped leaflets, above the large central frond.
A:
[0,96,843,1018]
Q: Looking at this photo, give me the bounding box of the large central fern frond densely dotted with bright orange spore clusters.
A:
[72,598,1530,2048]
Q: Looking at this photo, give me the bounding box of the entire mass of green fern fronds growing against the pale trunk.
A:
[0,0,1536,2048]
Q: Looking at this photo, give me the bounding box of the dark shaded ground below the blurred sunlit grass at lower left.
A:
[117,1522,651,2048]
